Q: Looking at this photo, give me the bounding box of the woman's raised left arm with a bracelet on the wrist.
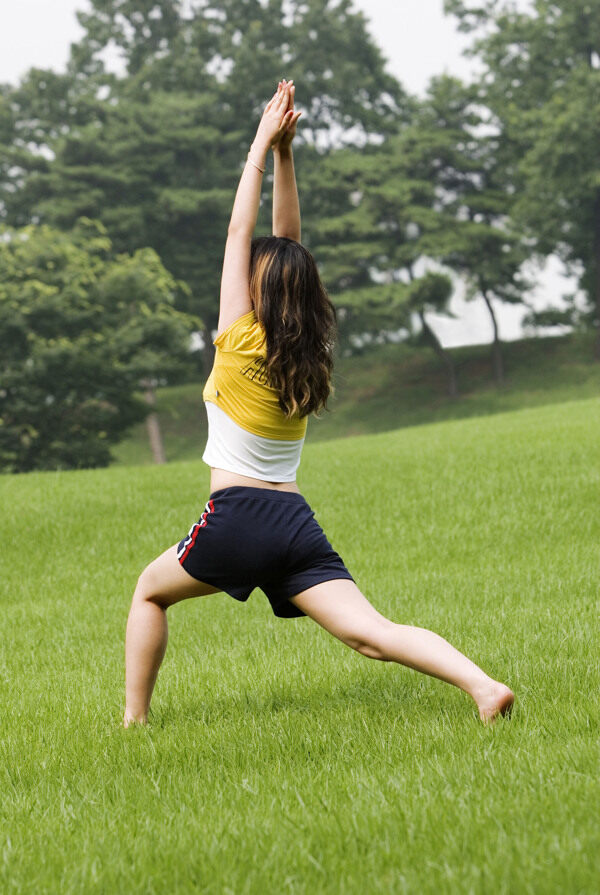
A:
[217,87,293,333]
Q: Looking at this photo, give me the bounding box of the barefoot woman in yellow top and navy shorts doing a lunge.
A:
[124,81,514,727]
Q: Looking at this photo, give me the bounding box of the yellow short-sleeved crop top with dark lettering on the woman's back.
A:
[202,310,307,441]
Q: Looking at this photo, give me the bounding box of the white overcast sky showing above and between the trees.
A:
[0,0,573,346]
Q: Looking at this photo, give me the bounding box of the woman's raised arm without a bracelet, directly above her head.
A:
[273,81,302,242]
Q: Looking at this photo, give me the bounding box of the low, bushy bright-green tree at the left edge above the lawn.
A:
[0,218,195,472]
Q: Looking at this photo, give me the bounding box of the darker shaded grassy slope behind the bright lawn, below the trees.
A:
[114,335,600,465]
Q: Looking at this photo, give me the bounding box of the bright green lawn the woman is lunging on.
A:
[0,400,600,895]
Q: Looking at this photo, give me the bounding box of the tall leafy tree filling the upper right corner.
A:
[446,0,600,360]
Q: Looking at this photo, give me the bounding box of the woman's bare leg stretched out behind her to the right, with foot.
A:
[291,578,514,723]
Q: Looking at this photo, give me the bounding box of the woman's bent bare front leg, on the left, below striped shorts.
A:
[123,545,218,727]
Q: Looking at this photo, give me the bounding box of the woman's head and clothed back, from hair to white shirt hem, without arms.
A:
[203,236,335,483]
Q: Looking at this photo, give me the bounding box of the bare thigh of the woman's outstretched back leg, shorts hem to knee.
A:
[290,578,391,647]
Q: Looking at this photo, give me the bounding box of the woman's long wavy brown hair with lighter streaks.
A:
[250,236,336,417]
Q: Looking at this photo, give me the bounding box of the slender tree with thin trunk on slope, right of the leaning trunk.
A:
[417,76,531,384]
